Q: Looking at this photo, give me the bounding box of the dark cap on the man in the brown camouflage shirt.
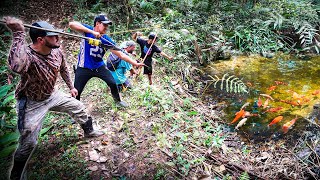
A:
[29,21,59,41]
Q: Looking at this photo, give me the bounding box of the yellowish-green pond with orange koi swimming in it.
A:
[205,55,320,140]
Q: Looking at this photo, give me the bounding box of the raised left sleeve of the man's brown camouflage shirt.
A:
[8,31,30,74]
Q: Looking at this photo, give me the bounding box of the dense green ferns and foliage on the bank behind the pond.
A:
[77,0,320,60]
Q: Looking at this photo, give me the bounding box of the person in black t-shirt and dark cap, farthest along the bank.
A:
[132,32,173,85]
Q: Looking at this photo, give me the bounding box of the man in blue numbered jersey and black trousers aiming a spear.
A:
[69,15,143,107]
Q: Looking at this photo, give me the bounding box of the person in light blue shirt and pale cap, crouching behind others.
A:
[107,41,136,91]
